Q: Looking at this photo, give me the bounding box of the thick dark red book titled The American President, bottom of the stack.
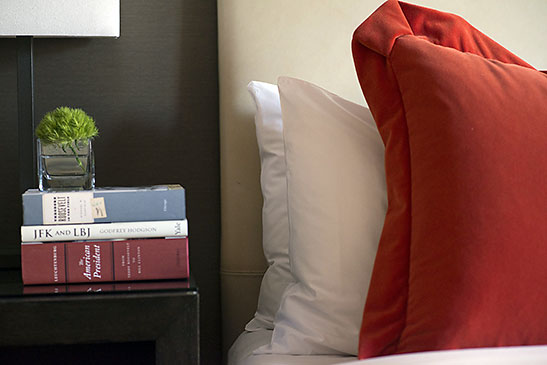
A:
[21,237,189,284]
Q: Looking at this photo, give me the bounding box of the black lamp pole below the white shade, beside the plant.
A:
[17,36,37,193]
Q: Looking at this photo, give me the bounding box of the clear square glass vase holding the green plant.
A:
[36,139,95,191]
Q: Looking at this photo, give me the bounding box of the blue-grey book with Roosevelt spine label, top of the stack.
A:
[23,185,186,226]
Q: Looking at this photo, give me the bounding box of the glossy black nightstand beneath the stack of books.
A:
[0,271,199,365]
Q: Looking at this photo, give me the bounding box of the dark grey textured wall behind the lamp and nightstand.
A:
[0,0,221,364]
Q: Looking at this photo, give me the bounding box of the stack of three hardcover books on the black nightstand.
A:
[21,185,189,285]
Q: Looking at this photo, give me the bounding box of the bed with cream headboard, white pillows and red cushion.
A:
[218,0,547,365]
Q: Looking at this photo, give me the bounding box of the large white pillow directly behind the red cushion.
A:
[255,77,387,355]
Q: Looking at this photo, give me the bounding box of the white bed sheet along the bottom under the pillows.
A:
[228,330,547,365]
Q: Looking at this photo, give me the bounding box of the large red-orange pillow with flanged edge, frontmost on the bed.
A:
[353,0,547,358]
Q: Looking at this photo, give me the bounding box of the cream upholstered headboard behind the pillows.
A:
[218,0,547,352]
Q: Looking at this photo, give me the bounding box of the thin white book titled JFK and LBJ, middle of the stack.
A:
[21,219,188,242]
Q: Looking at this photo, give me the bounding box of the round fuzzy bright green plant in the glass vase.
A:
[36,106,99,170]
